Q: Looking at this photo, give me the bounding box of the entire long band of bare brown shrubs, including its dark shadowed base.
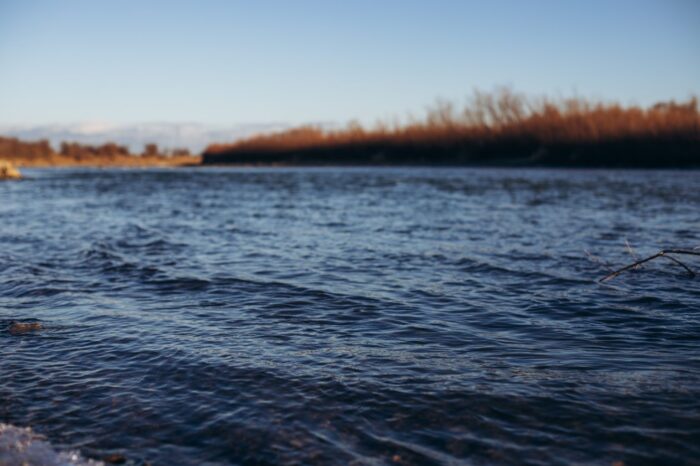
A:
[202,89,700,168]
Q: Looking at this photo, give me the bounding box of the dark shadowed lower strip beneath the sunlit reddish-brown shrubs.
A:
[202,140,700,168]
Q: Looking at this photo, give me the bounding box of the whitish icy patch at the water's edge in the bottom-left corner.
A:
[0,423,104,466]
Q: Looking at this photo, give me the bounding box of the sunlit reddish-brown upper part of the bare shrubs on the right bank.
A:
[206,89,700,154]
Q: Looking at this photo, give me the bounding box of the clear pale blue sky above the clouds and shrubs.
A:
[0,0,700,124]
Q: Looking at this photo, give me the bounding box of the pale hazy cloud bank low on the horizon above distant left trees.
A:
[0,122,290,153]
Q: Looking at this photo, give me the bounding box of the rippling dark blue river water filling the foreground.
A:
[0,168,700,465]
